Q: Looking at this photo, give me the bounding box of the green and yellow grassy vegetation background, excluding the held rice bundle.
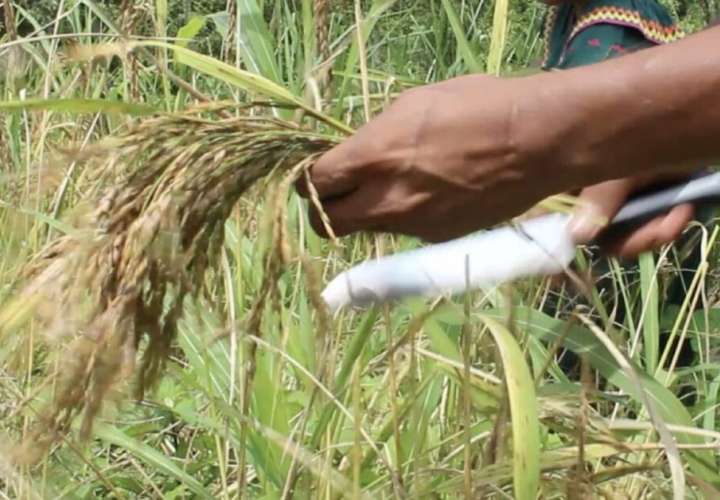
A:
[0,0,720,499]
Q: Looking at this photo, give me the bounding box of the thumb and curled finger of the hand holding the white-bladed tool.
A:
[571,177,694,258]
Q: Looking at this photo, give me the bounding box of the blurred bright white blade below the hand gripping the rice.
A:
[323,214,575,311]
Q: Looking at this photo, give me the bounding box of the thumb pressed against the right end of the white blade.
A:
[570,178,637,243]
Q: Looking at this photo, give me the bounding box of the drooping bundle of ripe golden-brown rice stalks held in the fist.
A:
[0,104,335,460]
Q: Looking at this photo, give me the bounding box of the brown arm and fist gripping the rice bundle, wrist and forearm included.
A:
[301,28,720,254]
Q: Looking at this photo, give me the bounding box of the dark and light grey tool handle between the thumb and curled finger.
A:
[603,172,720,237]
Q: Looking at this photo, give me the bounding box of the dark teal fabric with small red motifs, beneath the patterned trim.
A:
[558,23,655,69]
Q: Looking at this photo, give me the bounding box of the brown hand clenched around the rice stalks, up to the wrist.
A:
[298,75,569,241]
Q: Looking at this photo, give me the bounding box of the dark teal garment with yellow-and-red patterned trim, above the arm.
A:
[543,0,684,70]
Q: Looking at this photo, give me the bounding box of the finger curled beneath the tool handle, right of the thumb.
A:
[606,204,694,258]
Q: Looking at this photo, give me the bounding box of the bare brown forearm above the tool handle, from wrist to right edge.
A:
[515,28,720,188]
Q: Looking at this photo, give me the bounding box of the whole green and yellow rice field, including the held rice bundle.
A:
[0,0,720,499]
